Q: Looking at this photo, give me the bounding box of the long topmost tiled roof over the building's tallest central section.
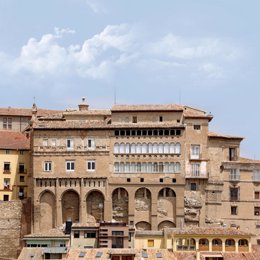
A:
[111,104,183,112]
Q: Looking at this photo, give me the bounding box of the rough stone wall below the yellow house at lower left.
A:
[0,201,31,259]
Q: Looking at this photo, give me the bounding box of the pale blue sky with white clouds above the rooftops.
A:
[0,0,260,159]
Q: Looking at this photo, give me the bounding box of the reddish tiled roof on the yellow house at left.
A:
[0,130,30,150]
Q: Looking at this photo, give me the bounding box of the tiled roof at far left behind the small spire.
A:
[0,107,62,117]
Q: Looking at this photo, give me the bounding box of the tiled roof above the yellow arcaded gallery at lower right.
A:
[166,227,253,236]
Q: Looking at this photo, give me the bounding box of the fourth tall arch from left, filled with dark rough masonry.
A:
[112,188,128,224]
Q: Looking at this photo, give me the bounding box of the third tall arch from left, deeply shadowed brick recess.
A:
[86,190,104,222]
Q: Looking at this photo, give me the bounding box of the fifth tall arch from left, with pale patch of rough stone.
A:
[135,188,151,212]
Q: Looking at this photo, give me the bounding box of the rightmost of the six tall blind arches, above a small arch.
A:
[157,187,176,223]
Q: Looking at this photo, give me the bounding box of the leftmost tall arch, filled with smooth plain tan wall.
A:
[39,190,56,231]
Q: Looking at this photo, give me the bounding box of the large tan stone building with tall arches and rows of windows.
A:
[31,99,260,245]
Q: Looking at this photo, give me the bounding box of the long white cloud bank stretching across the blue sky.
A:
[0,24,240,80]
